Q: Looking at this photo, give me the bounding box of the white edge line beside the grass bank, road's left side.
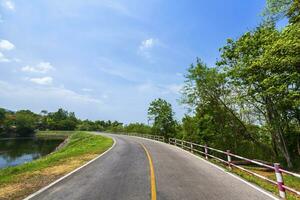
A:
[23,137,117,200]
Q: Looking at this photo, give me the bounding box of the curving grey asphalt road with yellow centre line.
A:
[32,135,274,200]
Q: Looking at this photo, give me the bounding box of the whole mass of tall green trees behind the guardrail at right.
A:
[182,10,300,168]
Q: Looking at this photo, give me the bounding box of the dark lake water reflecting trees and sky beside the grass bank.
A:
[0,138,63,169]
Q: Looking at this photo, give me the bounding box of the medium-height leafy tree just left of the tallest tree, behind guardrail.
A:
[181,59,270,159]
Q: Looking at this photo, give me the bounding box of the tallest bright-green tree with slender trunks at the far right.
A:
[218,23,300,167]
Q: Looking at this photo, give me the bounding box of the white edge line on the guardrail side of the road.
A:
[121,135,280,200]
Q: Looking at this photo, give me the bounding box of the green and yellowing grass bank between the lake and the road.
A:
[0,131,113,200]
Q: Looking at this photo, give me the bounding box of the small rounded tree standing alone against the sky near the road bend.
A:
[148,98,176,138]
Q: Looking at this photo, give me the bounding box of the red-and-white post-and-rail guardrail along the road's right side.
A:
[168,138,300,199]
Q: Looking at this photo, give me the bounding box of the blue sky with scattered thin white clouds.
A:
[0,0,265,123]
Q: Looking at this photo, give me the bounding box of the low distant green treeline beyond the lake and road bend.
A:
[0,108,151,137]
